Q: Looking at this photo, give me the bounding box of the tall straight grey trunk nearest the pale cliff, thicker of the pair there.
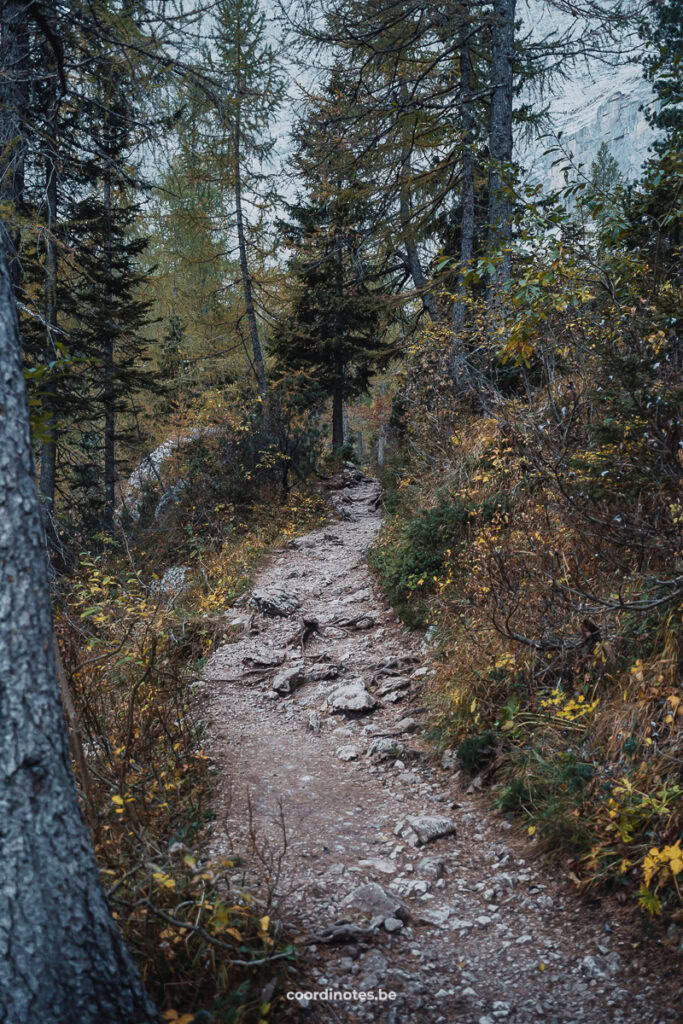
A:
[488,0,516,305]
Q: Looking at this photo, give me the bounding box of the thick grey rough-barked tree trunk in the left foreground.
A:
[0,243,159,1024]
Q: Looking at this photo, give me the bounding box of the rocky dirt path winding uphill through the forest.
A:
[204,472,680,1024]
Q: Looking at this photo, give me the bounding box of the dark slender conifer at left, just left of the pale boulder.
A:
[64,74,159,530]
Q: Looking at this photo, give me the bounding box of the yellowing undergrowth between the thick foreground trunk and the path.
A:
[56,421,328,1024]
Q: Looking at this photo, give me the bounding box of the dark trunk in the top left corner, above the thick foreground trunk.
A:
[0,0,29,287]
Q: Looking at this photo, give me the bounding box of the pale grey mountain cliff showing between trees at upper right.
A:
[516,0,655,190]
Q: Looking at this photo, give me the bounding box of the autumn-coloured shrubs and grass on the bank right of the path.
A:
[371,224,683,918]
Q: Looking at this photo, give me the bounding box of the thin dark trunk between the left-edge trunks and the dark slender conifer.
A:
[40,112,57,520]
